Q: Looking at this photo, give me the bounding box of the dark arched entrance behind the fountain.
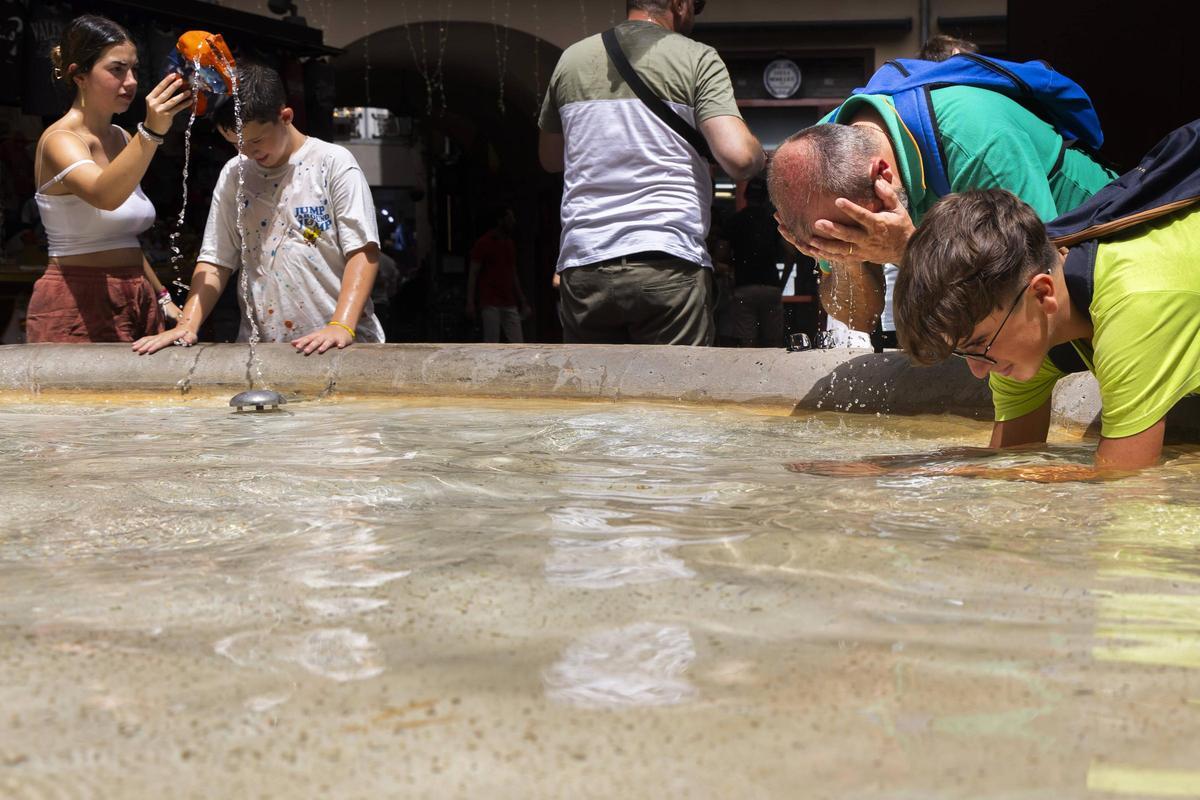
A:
[334,22,562,341]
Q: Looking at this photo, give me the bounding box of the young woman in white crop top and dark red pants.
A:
[25,14,191,342]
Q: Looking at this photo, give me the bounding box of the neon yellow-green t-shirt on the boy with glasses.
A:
[989,207,1200,439]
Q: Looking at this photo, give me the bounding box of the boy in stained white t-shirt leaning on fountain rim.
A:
[133,65,384,355]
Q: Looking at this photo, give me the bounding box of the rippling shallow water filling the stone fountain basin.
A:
[0,401,1200,798]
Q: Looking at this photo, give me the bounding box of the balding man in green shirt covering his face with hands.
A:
[769,86,1116,331]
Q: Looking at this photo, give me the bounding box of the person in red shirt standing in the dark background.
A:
[467,209,529,344]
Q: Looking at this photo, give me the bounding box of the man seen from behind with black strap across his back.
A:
[538,0,764,345]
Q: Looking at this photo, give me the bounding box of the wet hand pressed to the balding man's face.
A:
[788,178,914,264]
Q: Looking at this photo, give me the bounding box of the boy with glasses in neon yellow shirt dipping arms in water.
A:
[895,190,1200,477]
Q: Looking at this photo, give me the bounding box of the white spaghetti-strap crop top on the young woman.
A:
[35,126,155,257]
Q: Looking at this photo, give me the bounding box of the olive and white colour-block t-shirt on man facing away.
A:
[539,20,739,271]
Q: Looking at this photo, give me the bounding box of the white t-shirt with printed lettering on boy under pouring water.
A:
[199,137,384,342]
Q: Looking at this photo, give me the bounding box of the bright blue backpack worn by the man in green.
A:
[833,53,1104,197]
